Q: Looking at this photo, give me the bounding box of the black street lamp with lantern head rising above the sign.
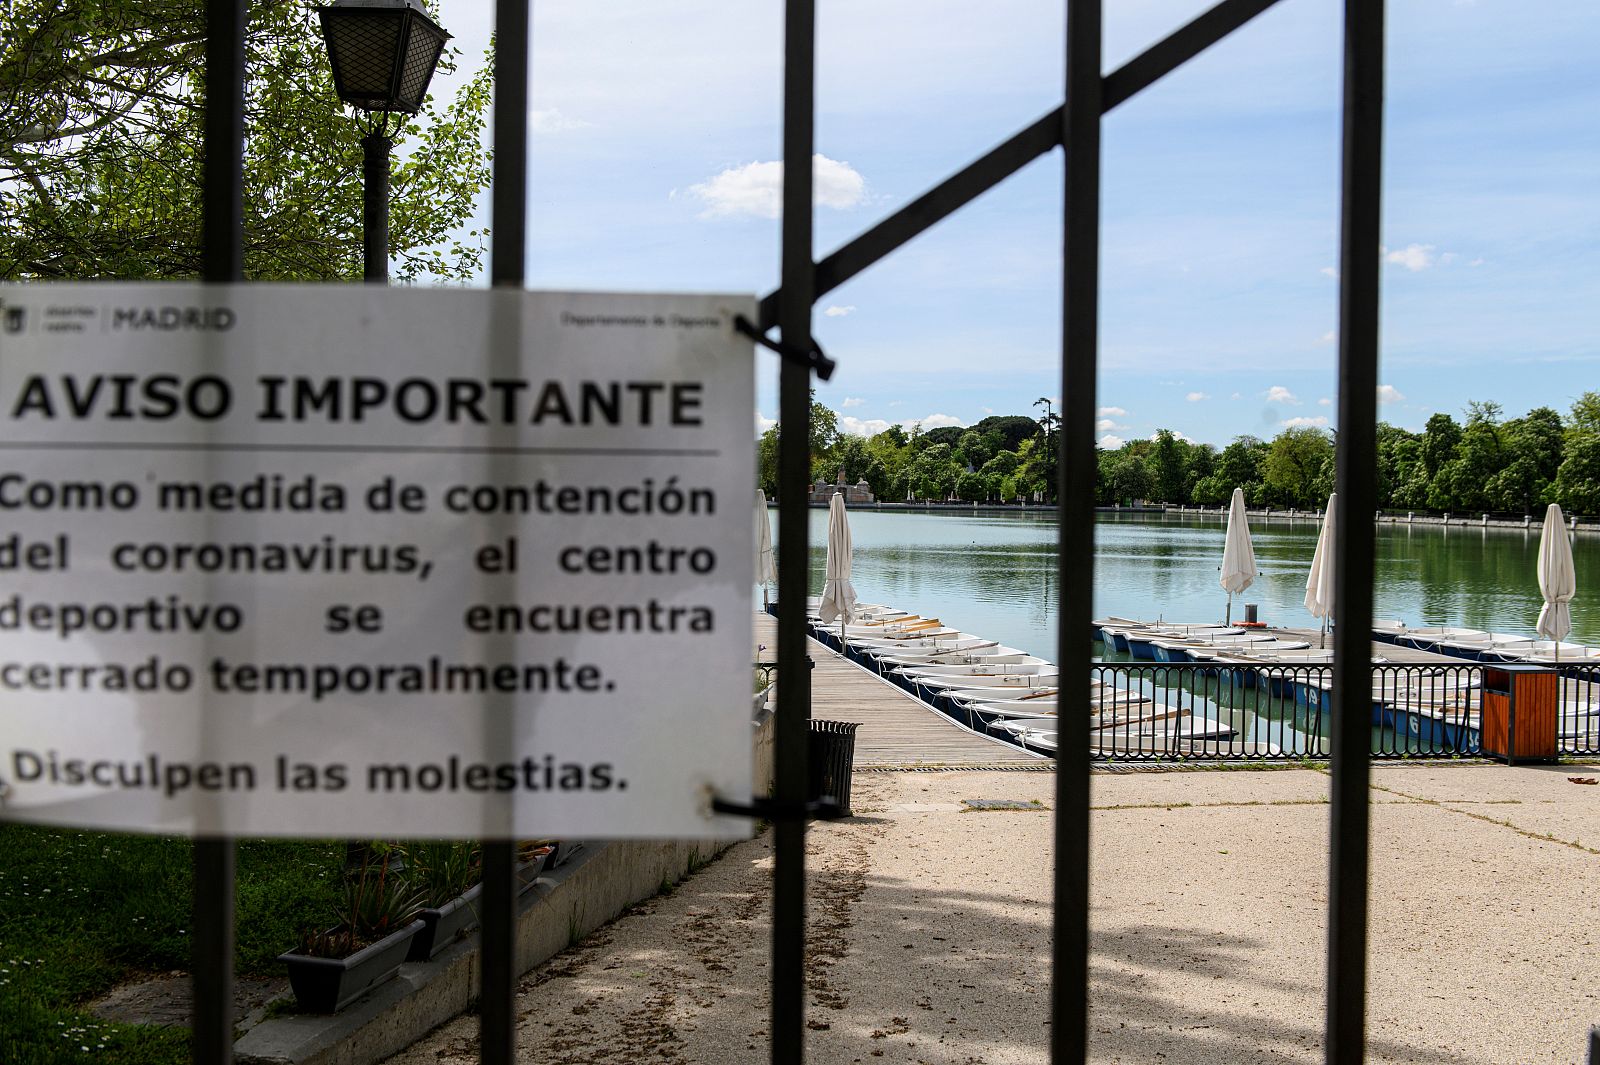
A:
[317,0,450,285]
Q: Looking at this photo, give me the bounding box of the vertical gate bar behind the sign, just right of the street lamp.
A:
[478,0,533,1065]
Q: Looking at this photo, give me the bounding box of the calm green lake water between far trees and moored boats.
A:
[771,510,1600,659]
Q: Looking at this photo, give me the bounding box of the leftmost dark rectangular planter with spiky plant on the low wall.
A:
[278,843,424,1014]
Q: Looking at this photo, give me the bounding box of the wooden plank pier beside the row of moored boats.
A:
[755,612,1056,769]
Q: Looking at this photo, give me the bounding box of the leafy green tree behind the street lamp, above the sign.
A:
[0,0,490,281]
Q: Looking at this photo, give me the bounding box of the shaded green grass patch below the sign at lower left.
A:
[0,824,344,1065]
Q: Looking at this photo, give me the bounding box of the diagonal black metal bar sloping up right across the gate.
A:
[757,0,1277,333]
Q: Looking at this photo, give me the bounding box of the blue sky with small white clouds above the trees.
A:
[435,0,1600,448]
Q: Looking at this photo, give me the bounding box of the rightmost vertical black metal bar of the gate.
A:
[1326,0,1384,1065]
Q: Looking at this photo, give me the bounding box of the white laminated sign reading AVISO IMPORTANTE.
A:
[0,285,755,838]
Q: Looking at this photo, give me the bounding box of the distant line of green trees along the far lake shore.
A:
[757,392,1600,515]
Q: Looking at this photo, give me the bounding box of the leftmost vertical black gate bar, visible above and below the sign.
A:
[189,0,245,1065]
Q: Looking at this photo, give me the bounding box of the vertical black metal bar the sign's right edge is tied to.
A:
[771,0,816,1065]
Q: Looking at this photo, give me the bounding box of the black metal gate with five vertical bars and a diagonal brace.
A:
[192,0,1384,1065]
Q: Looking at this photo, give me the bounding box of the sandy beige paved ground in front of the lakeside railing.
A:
[392,766,1600,1065]
